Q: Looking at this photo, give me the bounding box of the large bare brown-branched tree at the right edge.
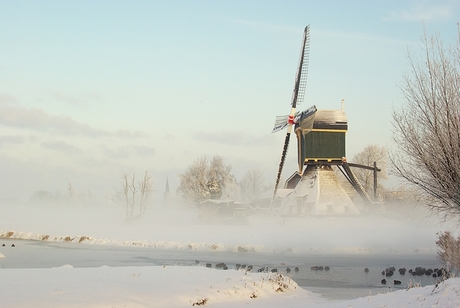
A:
[391,26,460,218]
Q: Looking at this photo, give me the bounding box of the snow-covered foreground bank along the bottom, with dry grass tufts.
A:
[0,265,460,308]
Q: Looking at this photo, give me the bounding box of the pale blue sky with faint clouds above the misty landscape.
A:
[0,0,460,200]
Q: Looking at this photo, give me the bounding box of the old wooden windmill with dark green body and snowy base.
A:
[270,25,380,216]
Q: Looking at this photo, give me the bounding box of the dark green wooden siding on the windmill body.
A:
[301,131,345,159]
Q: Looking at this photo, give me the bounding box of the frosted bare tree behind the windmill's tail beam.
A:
[353,144,388,193]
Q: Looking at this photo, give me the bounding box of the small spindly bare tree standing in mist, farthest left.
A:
[112,172,153,223]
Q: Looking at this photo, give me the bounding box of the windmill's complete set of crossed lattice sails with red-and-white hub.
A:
[270,25,316,202]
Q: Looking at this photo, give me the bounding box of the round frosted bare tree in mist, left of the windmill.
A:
[178,155,234,203]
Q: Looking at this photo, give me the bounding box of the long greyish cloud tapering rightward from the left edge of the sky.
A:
[0,106,147,138]
